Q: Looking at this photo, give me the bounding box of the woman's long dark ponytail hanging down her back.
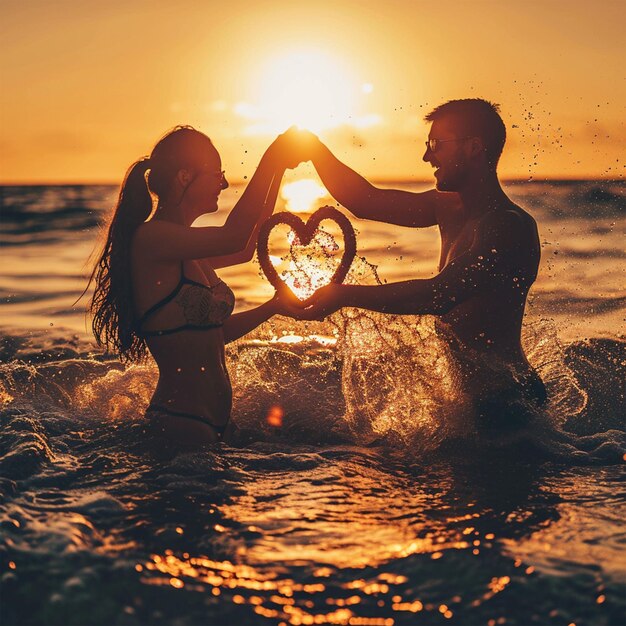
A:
[87,126,212,361]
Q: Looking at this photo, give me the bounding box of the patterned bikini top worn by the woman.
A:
[136,263,235,337]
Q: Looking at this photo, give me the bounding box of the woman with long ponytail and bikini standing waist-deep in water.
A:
[90,127,297,445]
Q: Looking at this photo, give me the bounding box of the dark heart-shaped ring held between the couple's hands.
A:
[257,206,356,298]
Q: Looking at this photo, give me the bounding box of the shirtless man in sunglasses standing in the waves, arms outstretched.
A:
[292,98,545,415]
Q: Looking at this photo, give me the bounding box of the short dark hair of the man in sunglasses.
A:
[424,98,506,169]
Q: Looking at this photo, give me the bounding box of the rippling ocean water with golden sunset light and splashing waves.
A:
[0,180,626,626]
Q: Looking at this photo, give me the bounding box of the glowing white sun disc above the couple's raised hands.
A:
[243,49,360,133]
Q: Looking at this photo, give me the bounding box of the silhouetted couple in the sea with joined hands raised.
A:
[90,99,546,445]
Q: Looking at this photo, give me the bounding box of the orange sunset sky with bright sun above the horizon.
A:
[0,0,626,183]
